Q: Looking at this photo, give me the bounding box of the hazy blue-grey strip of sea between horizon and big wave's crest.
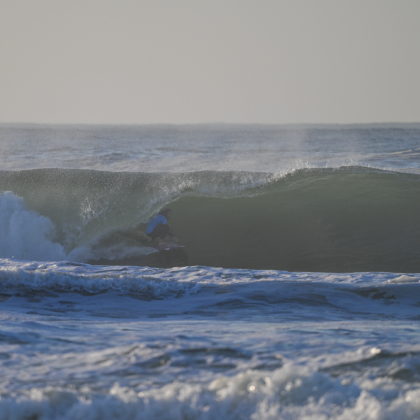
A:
[0,124,420,173]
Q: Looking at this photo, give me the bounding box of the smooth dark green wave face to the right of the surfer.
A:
[171,171,420,272]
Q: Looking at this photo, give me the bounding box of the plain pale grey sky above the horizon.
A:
[0,0,420,124]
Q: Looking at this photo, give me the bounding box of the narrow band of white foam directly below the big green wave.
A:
[0,258,418,293]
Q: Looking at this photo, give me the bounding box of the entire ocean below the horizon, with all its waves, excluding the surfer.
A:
[0,124,420,420]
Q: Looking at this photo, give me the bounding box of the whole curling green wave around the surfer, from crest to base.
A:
[0,167,420,272]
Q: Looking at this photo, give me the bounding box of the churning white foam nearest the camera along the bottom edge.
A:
[0,363,420,420]
